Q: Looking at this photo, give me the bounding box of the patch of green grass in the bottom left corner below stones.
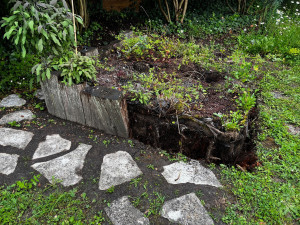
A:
[0,176,105,224]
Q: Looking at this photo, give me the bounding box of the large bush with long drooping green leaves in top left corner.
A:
[2,0,81,57]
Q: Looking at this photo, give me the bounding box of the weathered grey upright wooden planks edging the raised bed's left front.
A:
[41,72,128,138]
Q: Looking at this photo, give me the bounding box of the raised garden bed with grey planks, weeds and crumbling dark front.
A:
[42,34,257,169]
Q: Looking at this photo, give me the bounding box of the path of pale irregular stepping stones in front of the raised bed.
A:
[0,95,225,225]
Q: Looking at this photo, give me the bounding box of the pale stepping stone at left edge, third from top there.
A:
[0,128,34,149]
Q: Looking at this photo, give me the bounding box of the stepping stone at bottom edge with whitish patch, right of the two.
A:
[160,193,214,225]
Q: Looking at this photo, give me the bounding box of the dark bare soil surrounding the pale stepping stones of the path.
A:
[0,100,226,225]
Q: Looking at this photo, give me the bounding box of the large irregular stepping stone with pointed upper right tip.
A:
[31,144,92,187]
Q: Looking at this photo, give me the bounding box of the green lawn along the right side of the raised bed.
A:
[222,64,300,224]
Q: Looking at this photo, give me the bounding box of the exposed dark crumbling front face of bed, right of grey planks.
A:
[128,102,258,170]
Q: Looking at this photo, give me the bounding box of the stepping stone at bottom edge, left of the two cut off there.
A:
[104,196,150,225]
